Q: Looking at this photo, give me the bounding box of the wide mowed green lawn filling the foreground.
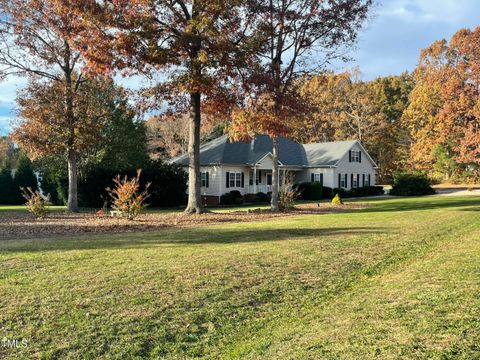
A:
[0,196,480,359]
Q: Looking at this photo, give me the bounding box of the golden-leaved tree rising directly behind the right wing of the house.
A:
[292,69,413,182]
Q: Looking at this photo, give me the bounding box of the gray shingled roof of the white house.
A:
[170,135,356,167]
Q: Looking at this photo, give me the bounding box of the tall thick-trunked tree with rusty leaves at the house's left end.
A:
[63,0,258,213]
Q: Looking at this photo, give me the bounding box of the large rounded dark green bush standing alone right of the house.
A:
[390,172,435,196]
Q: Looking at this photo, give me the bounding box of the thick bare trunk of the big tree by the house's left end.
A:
[185,91,203,214]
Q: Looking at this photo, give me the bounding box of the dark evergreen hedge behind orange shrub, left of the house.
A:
[76,161,187,208]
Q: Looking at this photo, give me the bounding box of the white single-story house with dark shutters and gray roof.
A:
[170,135,377,205]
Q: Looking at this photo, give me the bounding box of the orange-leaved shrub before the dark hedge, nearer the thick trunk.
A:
[106,170,150,220]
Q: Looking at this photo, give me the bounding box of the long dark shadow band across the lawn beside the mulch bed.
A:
[0,227,387,253]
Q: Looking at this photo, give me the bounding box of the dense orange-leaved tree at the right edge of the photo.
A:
[404,27,480,178]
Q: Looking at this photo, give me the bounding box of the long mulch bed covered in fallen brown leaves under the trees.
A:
[0,203,367,240]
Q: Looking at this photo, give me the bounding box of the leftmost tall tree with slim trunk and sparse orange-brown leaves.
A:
[0,0,91,211]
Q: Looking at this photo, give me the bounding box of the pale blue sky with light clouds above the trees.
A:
[0,0,480,135]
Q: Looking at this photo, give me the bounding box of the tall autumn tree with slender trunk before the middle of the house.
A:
[231,0,372,211]
